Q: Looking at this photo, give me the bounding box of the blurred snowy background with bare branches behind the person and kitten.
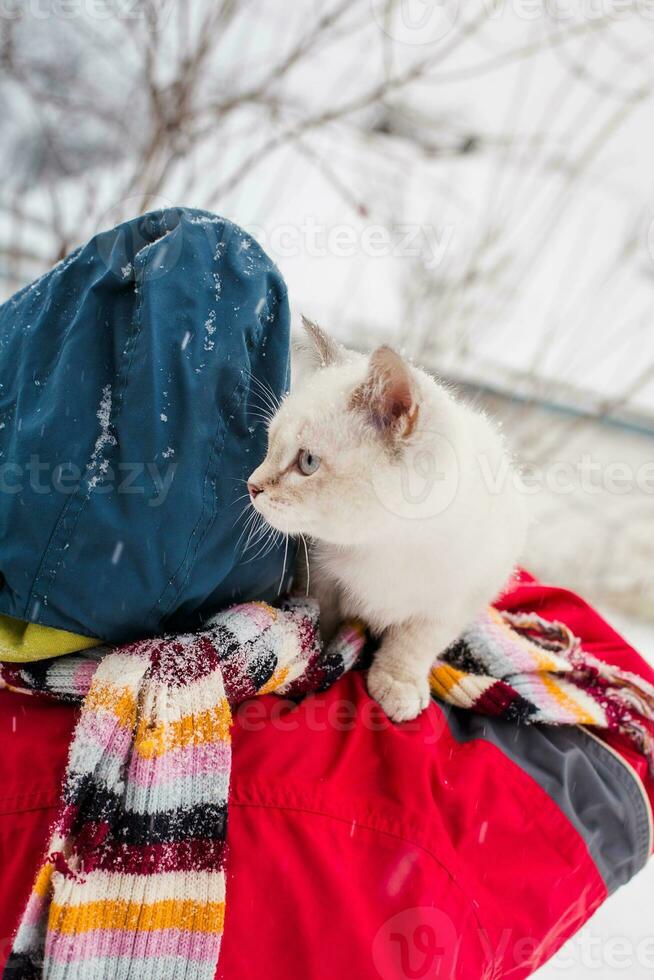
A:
[0,0,654,980]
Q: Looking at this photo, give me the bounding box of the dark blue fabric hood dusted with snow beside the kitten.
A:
[0,208,289,643]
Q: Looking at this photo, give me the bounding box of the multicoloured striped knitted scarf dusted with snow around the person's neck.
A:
[0,599,654,980]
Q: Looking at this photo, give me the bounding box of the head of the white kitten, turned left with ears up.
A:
[248,325,428,545]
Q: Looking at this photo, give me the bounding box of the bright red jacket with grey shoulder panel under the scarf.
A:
[0,576,654,980]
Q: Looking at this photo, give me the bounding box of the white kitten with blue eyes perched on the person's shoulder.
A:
[248,320,526,721]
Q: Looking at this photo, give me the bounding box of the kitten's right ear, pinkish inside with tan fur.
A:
[352,346,419,438]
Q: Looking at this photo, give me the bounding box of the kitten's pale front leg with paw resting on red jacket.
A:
[368,620,456,721]
